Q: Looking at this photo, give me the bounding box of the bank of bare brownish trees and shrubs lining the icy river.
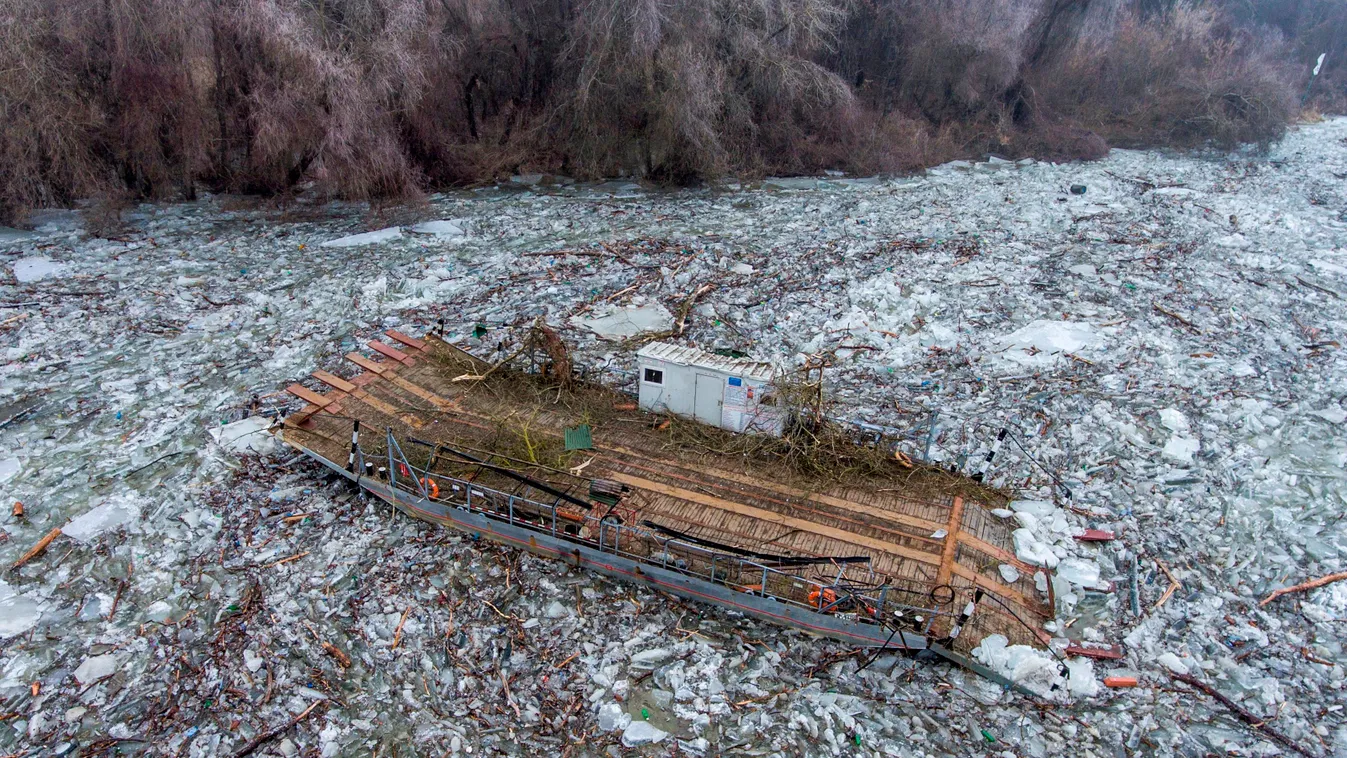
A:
[0,0,1314,218]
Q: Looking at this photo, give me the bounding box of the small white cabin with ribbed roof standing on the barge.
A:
[636,342,785,436]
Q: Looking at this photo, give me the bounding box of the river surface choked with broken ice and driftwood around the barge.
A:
[0,120,1347,757]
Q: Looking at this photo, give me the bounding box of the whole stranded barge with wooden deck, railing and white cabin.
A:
[279,324,1052,685]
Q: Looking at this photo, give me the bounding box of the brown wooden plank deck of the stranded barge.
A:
[283,331,1051,645]
